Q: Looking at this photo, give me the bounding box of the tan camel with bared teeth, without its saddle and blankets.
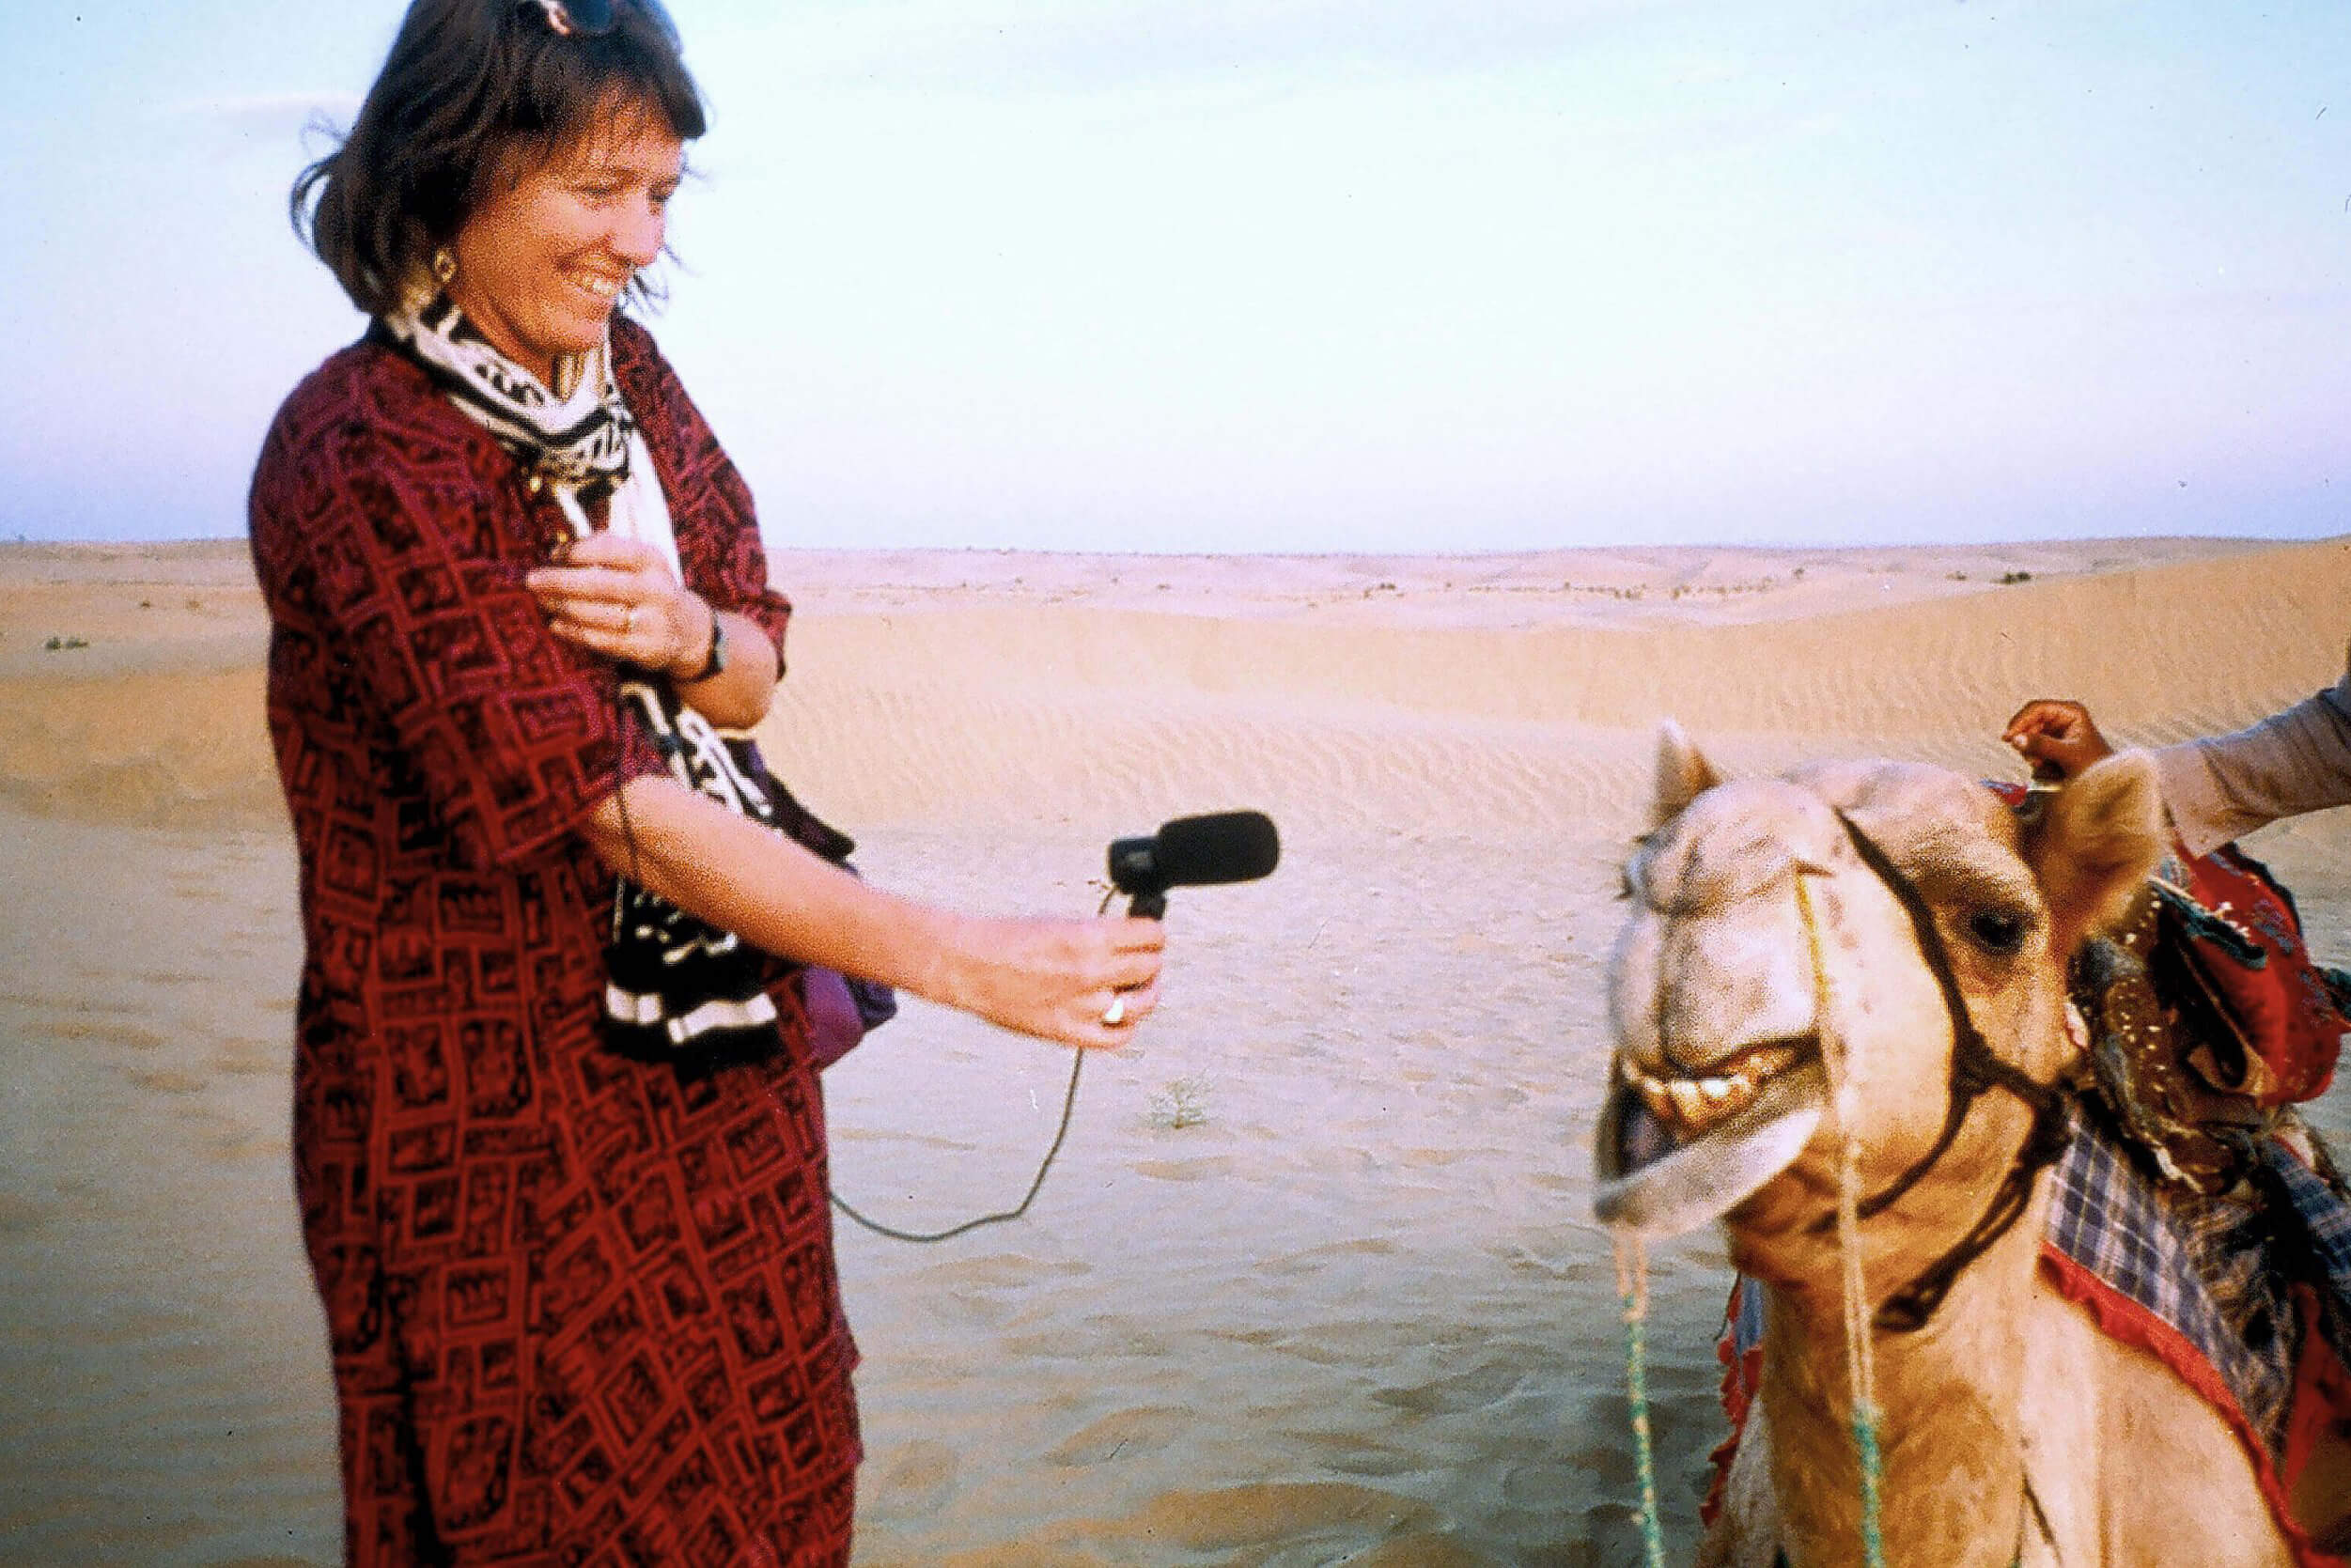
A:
[1596,726,2343,1568]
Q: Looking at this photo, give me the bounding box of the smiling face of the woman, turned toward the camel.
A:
[449,113,687,383]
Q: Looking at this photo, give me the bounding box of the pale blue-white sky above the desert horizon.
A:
[0,0,2351,551]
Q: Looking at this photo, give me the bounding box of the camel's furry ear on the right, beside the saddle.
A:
[2022,753,2168,956]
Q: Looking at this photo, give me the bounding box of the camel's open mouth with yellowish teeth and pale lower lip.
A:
[1592,1034,1829,1236]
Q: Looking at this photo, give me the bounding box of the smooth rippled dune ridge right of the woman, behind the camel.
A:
[771,543,2351,832]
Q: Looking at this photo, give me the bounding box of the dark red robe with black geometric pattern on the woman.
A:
[252,319,858,1568]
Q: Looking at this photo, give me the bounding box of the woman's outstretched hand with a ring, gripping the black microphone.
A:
[917,917,1166,1047]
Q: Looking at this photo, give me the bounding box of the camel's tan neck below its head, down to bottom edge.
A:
[1764,1202,2043,1568]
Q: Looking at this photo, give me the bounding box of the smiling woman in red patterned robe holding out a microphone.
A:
[252,0,1159,1568]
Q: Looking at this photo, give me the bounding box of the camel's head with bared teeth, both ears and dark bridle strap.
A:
[1596,726,2165,1281]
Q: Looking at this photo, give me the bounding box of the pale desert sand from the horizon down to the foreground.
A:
[0,541,2351,1568]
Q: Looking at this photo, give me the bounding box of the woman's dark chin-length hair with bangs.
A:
[289,0,703,315]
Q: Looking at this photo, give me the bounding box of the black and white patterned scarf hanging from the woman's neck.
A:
[381,294,836,1058]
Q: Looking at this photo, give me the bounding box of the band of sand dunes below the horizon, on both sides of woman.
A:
[0,541,2351,830]
